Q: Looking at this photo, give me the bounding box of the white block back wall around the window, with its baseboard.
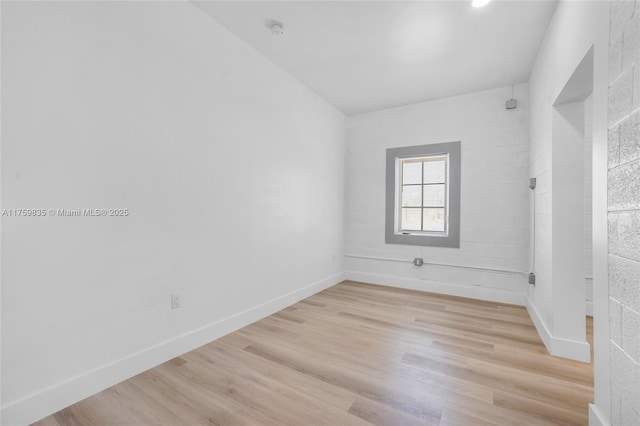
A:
[345,85,529,304]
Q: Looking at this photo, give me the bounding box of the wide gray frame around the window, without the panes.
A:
[385,141,461,248]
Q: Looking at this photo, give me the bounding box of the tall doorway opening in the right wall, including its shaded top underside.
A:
[551,48,593,362]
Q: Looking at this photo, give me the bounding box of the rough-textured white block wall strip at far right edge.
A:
[608,1,640,425]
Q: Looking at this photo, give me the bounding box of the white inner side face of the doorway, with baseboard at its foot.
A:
[552,100,591,356]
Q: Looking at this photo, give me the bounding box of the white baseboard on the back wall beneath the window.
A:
[345,271,526,306]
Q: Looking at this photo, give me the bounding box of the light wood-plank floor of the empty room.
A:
[37,281,593,426]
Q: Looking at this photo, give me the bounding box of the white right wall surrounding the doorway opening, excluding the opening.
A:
[528,1,610,422]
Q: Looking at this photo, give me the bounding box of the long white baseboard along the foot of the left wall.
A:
[1,273,344,426]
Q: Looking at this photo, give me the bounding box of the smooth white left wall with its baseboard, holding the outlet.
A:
[2,2,345,424]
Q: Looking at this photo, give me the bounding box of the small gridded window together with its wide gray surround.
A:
[385,142,460,247]
